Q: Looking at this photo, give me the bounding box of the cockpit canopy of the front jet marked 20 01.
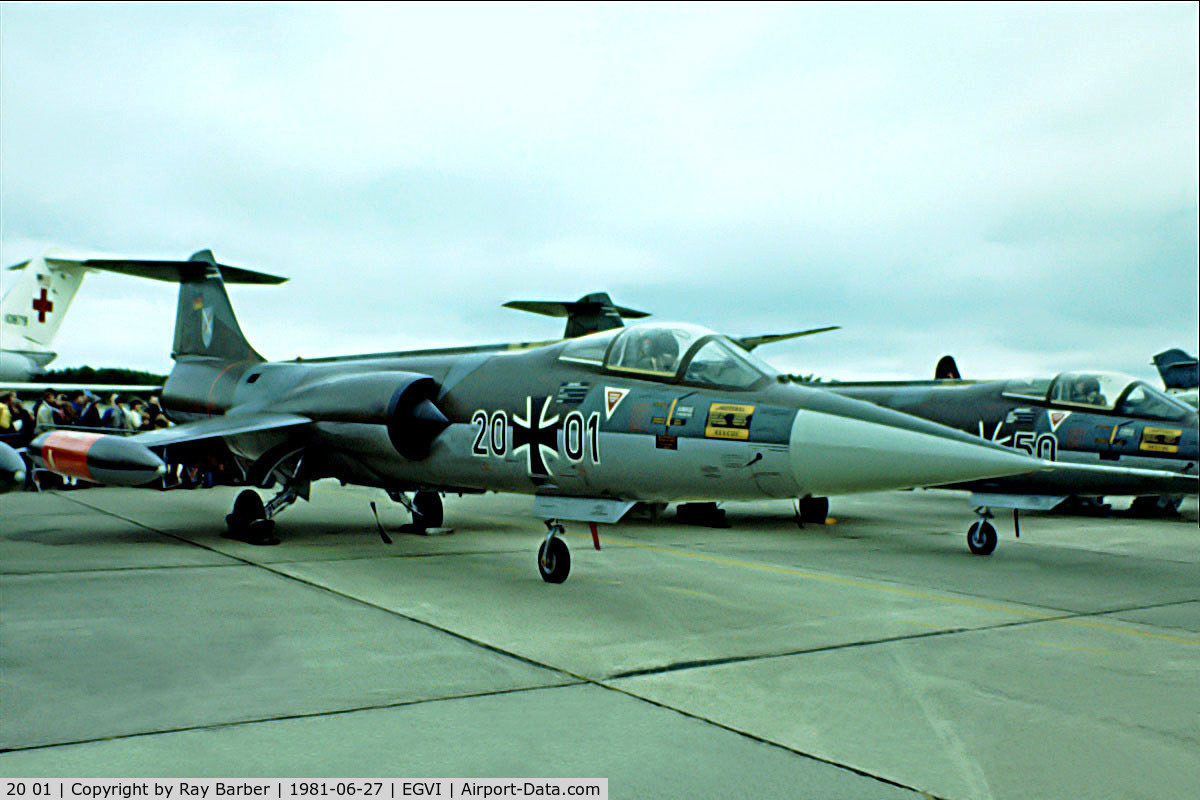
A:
[559,323,778,389]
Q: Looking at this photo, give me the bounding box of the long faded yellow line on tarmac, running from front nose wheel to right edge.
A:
[568,534,1200,648]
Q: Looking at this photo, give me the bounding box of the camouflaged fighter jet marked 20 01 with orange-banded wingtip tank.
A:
[23,251,1043,583]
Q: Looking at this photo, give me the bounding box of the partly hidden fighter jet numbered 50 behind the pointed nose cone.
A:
[822,356,1200,552]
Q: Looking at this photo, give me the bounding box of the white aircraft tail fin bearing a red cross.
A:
[2,249,86,349]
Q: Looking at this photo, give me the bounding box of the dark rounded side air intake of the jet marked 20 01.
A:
[277,372,450,461]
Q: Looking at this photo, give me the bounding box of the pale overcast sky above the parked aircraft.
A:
[0,2,1200,379]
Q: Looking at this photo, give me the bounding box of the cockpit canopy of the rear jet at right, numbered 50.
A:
[1003,372,1192,420]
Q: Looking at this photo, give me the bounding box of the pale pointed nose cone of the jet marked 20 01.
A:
[791,410,1043,494]
